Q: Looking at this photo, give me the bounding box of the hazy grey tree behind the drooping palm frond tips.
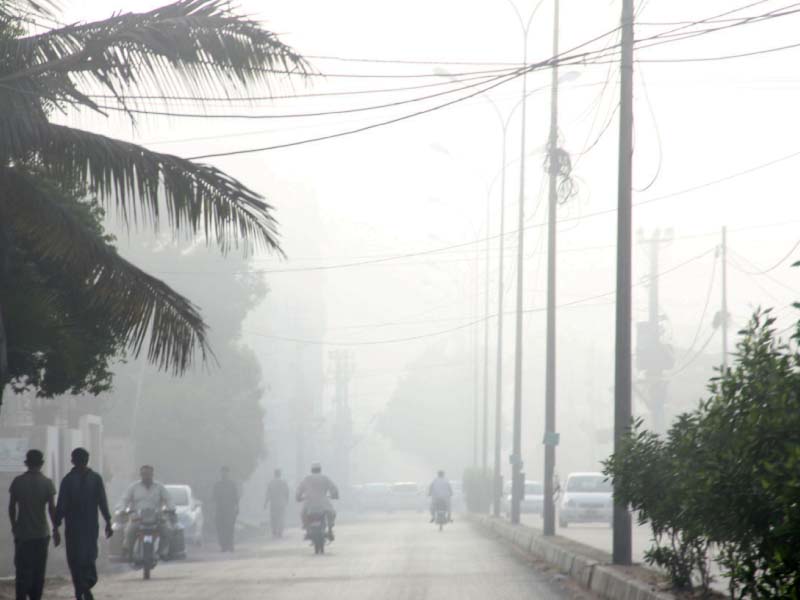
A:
[104,234,267,499]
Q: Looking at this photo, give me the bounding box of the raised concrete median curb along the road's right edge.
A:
[469,515,676,600]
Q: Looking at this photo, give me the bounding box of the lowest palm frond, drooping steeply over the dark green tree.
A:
[0,168,210,373]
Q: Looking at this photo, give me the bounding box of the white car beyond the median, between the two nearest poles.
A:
[558,473,614,527]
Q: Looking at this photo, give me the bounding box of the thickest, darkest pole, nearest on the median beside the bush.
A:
[613,0,634,565]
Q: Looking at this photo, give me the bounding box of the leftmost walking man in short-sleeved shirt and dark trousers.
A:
[8,450,61,600]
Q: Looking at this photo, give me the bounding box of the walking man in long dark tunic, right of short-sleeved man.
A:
[54,448,113,600]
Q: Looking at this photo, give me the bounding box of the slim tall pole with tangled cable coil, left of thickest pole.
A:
[542,0,561,535]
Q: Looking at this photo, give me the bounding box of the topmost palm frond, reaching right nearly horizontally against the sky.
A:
[0,0,308,114]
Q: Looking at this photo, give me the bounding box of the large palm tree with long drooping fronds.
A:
[0,0,306,402]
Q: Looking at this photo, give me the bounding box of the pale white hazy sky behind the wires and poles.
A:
[54,0,800,478]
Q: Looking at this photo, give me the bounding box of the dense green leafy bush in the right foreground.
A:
[605,305,800,598]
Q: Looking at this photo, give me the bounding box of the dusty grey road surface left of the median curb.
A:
[43,513,592,600]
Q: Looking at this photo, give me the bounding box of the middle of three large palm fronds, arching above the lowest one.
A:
[8,122,281,252]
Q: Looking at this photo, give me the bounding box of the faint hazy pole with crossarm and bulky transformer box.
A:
[636,229,675,434]
